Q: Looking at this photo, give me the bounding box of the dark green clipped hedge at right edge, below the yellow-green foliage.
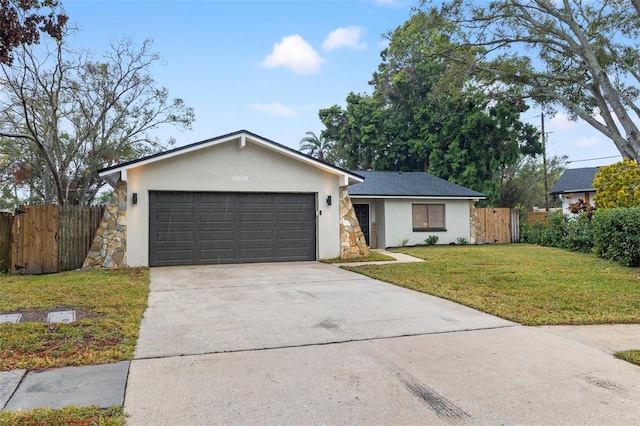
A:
[592,208,640,266]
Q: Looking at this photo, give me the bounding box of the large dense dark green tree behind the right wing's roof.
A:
[319,12,541,203]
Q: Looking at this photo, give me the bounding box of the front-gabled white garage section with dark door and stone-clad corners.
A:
[94,130,364,267]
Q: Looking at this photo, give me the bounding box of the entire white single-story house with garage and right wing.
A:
[84,130,482,267]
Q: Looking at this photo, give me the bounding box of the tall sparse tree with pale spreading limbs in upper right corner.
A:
[421,0,640,160]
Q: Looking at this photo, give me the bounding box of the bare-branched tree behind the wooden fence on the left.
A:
[0,35,194,205]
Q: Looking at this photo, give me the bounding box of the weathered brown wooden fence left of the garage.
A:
[0,206,104,274]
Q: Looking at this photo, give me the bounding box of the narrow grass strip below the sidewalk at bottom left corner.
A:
[0,407,127,426]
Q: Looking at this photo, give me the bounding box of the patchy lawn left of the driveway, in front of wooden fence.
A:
[0,268,149,371]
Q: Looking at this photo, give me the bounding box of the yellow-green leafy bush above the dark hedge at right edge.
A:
[593,158,640,209]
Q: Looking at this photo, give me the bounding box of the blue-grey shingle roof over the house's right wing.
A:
[349,171,485,198]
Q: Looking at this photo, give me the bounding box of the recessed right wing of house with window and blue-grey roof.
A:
[348,171,485,248]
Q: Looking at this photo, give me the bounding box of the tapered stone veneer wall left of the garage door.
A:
[82,181,127,269]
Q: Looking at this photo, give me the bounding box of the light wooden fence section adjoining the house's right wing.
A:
[472,208,520,244]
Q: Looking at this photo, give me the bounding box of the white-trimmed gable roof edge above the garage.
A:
[98,130,363,185]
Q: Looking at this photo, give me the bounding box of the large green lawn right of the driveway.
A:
[345,244,640,325]
